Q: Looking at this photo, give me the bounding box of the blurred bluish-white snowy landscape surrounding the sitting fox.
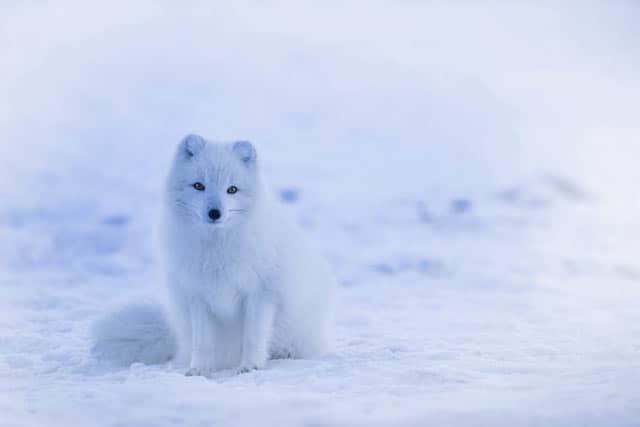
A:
[0,0,640,427]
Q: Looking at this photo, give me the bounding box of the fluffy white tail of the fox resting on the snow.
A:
[91,304,176,366]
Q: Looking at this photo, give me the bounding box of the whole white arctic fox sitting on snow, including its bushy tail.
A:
[94,135,335,376]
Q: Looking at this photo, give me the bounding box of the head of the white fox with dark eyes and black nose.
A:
[167,135,259,230]
